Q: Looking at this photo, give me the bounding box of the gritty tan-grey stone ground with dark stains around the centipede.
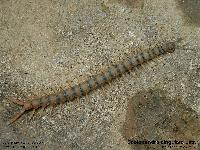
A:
[0,0,200,150]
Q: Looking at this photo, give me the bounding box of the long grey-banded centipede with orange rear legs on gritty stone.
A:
[9,42,176,124]
